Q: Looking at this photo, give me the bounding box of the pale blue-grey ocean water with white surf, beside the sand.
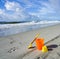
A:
[0,21,60,37]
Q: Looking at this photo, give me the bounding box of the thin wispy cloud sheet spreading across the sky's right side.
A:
[29,0,60,20]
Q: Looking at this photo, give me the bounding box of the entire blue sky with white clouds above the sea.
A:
[0,0,60,21]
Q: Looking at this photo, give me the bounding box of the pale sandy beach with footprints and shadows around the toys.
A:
[0,24,60,59]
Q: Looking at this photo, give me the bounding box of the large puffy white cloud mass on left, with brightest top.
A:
[0,1,29,21]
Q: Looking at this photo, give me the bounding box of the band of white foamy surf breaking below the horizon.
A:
[0,20,60,29]
